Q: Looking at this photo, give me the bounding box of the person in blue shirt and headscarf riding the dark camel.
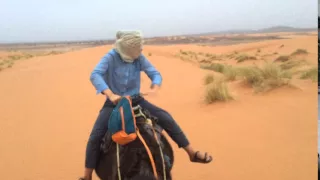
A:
[80,31,212,180]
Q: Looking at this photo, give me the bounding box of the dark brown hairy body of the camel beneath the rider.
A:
[95,103,174,180]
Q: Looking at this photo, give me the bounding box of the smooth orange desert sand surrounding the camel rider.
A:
[0,36,317,180]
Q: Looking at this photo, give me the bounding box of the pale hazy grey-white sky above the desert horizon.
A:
[0,0,318,42]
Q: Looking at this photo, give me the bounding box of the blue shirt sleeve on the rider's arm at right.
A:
[140,55,162,86]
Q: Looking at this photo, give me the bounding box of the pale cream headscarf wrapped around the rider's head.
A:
[114,31,143,63]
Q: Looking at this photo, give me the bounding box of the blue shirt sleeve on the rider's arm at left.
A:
[90,54,110,94]
